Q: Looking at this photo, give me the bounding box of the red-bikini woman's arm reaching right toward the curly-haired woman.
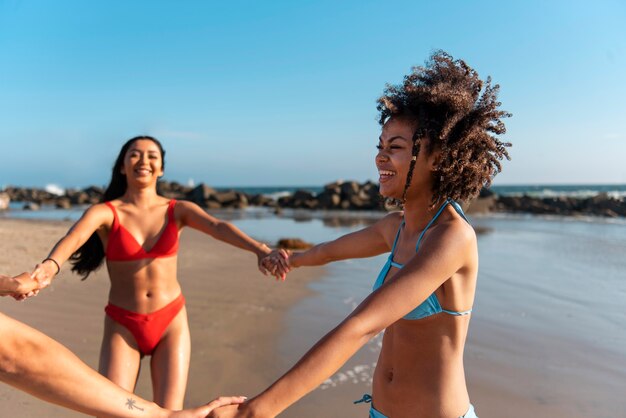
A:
[176,201,287,278]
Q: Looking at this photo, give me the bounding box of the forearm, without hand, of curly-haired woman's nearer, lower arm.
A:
[246,318,375,417]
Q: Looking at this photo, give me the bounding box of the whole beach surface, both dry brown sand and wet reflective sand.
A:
[0,218,626,418]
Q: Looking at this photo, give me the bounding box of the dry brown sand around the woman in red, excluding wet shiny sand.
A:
[0,219,323,418]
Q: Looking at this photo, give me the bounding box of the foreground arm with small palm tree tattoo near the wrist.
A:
[0,314,244,418]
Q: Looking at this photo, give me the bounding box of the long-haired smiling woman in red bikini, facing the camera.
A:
[33,136,285,409]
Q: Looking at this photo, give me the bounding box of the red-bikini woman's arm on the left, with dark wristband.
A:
[32,204,113,287]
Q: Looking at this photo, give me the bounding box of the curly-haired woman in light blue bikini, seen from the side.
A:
[210,52,510,418]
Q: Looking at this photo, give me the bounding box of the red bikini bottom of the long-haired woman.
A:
[104,293,185,355]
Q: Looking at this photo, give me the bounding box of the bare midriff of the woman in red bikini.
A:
[107,256,181,314]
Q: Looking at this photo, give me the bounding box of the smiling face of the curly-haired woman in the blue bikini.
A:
[376,117,435,199]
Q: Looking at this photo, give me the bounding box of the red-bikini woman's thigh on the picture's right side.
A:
[150,307,191,410]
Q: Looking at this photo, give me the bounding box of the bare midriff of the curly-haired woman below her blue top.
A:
[372,313,469,418]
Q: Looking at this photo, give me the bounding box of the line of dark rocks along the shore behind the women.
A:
[0,181,626,217]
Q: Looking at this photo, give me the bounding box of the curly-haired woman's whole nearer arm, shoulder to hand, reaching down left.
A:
[210,220,475,418]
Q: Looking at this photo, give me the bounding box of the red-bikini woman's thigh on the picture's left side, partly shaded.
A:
[98,315,141,392]
